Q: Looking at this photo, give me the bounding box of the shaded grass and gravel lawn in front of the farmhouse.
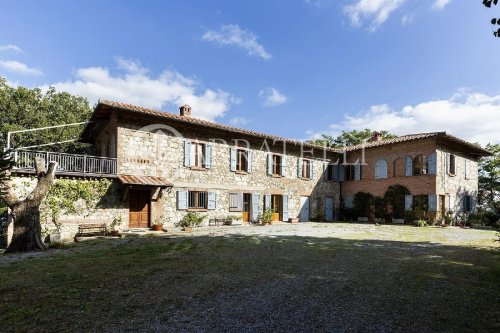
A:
[0,223,500,332]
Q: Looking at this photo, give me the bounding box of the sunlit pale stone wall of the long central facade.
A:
[118,120,339,225]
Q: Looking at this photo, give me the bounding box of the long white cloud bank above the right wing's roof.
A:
[309,89,500,145]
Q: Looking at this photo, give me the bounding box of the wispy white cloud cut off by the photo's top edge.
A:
[344,0,405,31]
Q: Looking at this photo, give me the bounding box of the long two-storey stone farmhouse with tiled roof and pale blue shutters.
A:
[6,100,489,237]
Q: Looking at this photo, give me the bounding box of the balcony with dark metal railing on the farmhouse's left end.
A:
[12,150,117,178]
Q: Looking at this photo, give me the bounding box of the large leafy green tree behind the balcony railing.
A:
[0,77,92,153]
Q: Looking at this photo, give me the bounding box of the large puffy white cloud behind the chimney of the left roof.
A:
[42,58,239,120]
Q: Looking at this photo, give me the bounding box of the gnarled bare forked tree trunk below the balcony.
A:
[3,157,57,253]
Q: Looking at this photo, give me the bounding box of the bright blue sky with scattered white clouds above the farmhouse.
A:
[0,0,500,144]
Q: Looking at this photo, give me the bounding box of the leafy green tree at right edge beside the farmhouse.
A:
[479,144,500,223]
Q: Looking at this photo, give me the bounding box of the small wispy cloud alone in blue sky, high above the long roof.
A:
[202,24,272,60]
